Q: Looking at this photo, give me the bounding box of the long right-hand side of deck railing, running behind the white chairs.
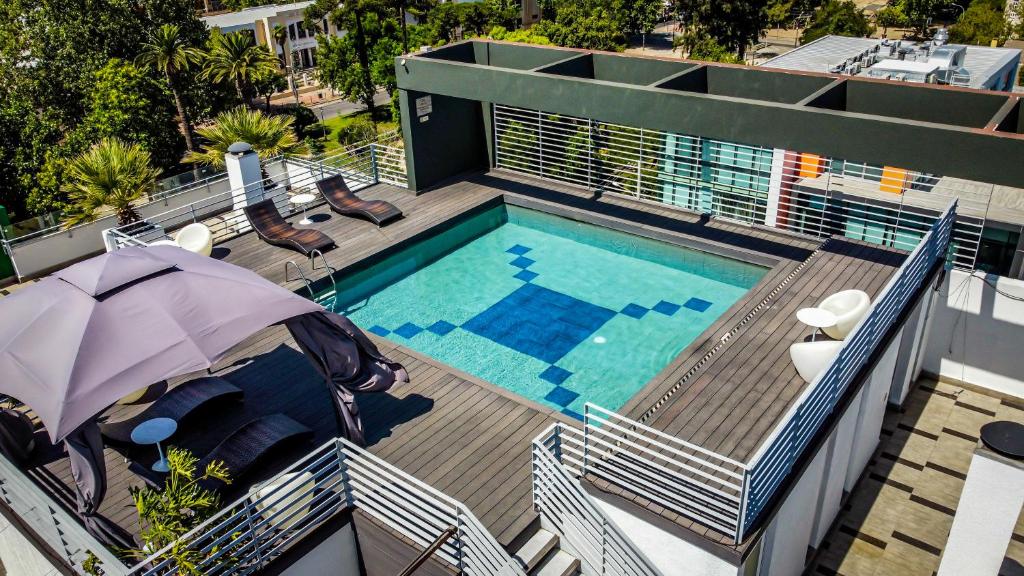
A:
[744,202,956,527]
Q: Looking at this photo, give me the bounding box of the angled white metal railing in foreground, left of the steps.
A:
[131,439,524,576]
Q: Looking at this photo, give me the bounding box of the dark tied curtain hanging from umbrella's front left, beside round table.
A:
[65,420,134,549]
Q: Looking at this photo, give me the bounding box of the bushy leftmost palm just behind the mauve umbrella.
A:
[62,138,160,228]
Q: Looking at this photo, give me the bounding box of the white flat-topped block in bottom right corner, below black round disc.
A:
[938,447,1024,576]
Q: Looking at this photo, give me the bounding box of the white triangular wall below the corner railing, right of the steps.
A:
[594,499,739,576]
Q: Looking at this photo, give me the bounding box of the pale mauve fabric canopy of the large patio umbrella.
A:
[0,246,324,442]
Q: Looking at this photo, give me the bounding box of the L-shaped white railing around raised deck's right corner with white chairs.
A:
[534,201,956,541]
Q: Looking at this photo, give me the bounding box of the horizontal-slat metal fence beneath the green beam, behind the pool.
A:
[494,106,995,270]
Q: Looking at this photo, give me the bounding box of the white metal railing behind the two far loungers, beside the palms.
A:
[112,142,407,247]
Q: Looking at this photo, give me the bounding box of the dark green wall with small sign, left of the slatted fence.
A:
[398,89,489,192]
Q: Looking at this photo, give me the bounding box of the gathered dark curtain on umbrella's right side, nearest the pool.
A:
[285,312,409,446]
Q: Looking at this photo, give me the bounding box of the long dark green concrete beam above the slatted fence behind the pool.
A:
[398,43,1024,187]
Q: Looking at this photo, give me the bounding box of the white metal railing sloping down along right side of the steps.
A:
[532,422,660,576]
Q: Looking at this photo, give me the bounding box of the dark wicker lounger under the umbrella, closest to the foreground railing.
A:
[196,414,313,490]
